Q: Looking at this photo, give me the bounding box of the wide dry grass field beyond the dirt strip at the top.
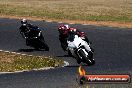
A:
[0,0,132,22]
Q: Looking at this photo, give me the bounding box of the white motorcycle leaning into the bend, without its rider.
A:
[67,35,95,65]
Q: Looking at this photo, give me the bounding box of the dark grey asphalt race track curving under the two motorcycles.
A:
[0,19,132,88]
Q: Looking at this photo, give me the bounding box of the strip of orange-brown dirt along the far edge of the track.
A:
[0,15,132,28]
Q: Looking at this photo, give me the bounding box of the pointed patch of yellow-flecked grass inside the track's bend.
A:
[0,52,63,72]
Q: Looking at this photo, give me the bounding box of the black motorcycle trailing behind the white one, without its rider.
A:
[20,27,49,51]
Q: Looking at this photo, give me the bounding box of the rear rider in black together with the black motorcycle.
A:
[19,19,49,51]
